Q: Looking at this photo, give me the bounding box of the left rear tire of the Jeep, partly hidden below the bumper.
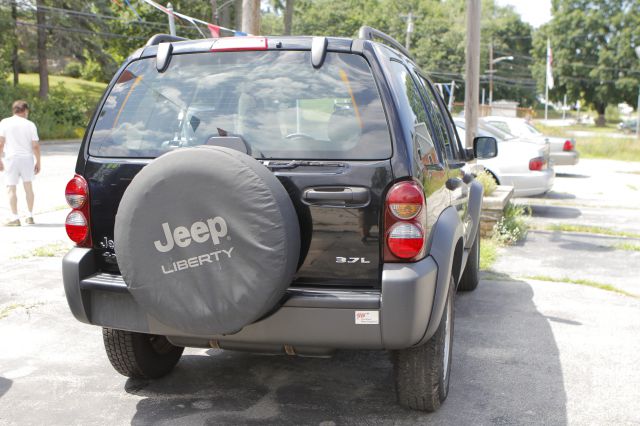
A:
[102,328,184,379]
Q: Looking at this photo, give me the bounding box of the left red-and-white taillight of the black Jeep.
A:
[64,175,91,247]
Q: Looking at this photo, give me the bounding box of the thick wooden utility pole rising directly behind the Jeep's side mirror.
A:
[464,0,481,148]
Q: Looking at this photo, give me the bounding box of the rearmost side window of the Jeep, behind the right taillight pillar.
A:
[391,61,444,170]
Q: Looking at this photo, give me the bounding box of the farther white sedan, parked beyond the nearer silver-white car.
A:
[481,116,580,166]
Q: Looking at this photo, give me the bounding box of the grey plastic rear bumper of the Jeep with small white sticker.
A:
[63,248,439,354]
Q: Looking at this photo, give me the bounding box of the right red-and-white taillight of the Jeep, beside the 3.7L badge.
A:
[384,181,427,262]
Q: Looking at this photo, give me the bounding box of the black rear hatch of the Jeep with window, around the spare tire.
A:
[84,45,393,287]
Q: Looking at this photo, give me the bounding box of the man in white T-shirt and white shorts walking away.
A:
[0,101,40,226]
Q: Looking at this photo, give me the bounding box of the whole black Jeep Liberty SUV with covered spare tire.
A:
[63,27,497,411]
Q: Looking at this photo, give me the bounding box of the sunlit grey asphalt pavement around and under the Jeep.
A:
[0,145,640,425]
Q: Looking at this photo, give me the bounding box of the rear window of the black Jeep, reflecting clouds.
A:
[89,51,391,159]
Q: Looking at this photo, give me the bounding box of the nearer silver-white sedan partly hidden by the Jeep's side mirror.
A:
[454,120,555,197]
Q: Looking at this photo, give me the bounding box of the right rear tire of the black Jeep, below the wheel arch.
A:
[392,279,455,412]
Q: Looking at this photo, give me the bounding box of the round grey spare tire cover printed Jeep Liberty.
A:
[114,146,300,336]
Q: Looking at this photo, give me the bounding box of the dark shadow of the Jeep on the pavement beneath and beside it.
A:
[125,281,566,425]
